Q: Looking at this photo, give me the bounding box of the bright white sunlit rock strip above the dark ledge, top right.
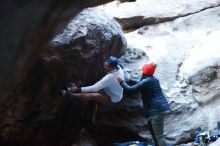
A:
[99,0,220,18]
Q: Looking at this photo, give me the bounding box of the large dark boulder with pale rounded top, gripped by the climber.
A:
[0,8,128,146]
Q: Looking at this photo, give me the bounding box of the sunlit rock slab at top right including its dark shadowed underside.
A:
[99,0,220,31]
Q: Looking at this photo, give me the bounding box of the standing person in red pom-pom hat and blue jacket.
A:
[117,62,170,146]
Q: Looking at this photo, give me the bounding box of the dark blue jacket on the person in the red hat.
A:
[120,75,170,118]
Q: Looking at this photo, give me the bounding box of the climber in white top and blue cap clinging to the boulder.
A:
[61,56,124,122]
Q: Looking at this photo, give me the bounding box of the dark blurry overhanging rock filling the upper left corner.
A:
[0,0,117,102]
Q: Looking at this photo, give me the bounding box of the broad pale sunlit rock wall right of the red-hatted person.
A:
[136,8,220,143]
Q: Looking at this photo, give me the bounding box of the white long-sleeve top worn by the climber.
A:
[81,67,124,103]
